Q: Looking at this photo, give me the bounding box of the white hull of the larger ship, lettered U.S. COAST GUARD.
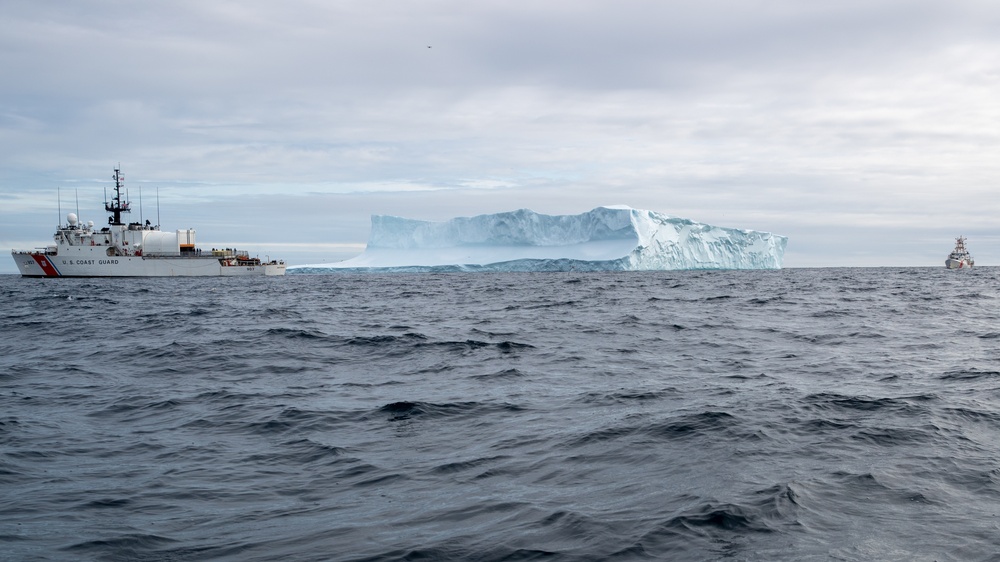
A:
[13,247,285,277]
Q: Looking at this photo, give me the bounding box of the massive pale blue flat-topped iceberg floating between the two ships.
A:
[288,205,788,273]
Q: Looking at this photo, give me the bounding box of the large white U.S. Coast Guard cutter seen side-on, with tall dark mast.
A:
[11,168,285,277]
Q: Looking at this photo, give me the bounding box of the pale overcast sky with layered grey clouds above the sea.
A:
[0,0,1000,273]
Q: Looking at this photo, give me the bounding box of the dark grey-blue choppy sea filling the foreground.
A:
[0,268,1000,560]
